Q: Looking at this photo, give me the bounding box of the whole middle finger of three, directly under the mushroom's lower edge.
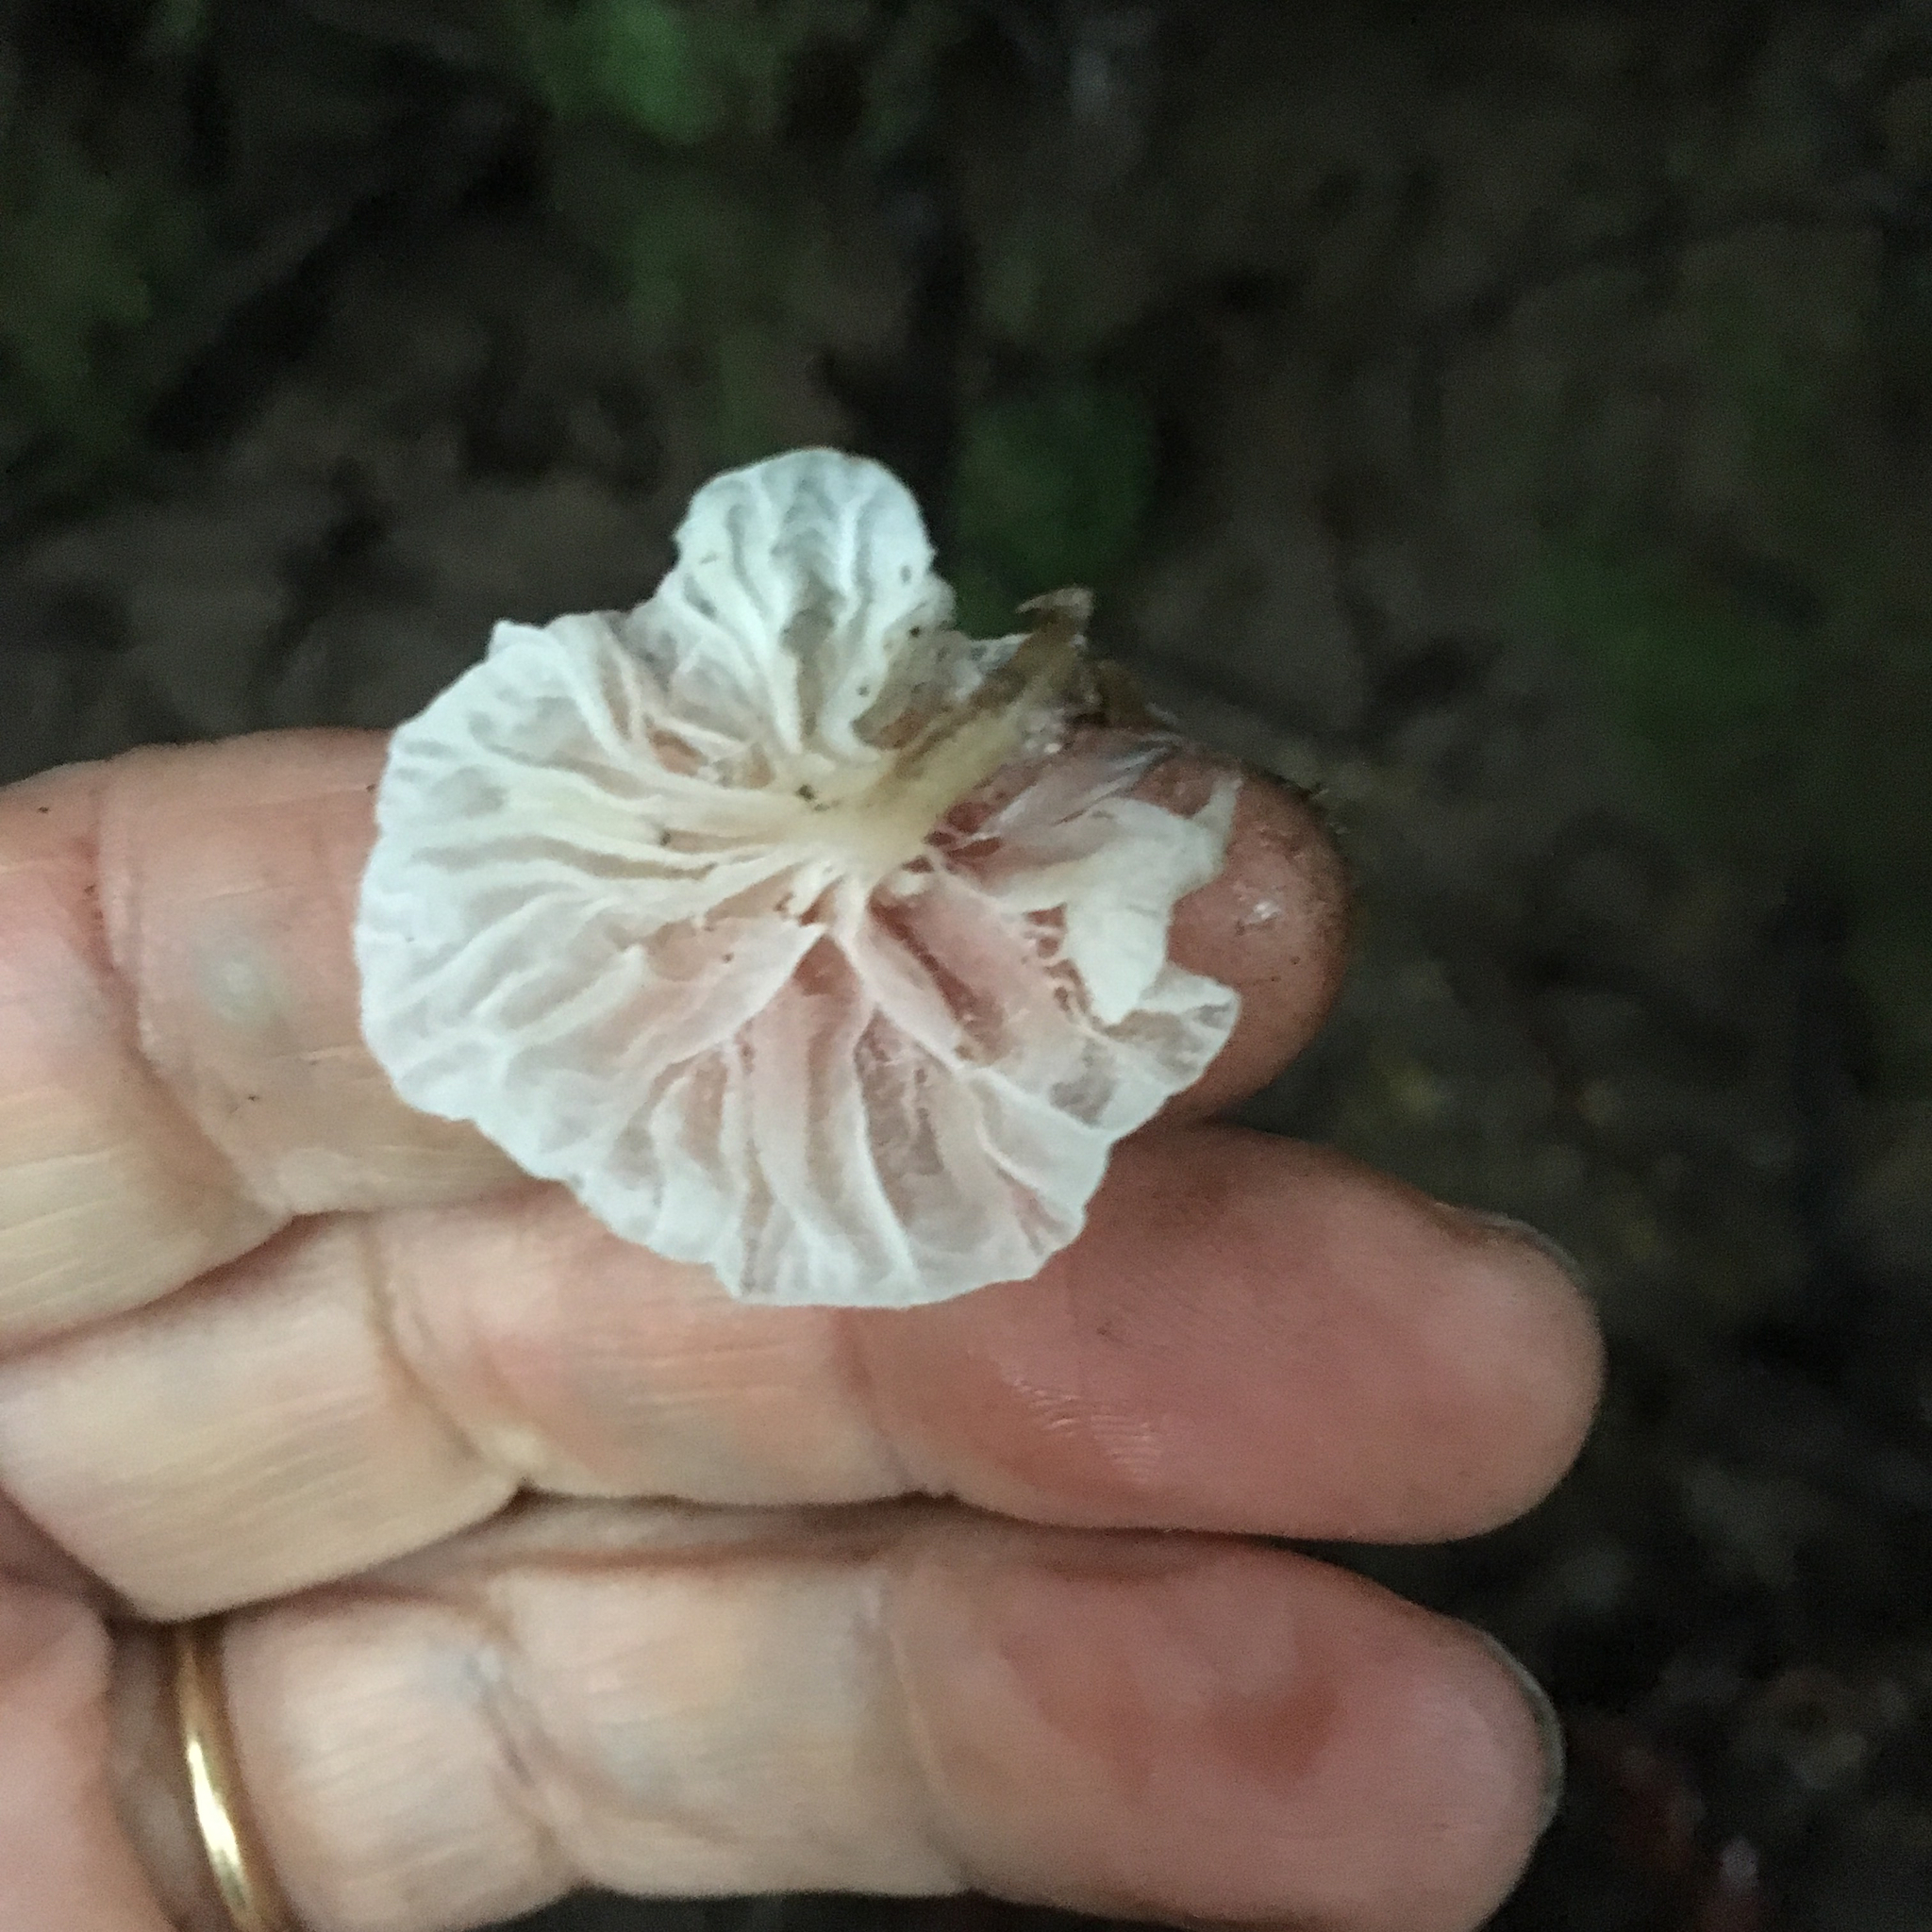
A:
[0,1126,1602,1617]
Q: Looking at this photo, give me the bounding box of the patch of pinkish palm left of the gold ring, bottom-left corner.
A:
[0,1582,168,1932]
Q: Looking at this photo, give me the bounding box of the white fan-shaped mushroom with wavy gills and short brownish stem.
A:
[356,450,1237,1306]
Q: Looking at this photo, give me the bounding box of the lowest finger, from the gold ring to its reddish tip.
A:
[121,1508,1549,1932]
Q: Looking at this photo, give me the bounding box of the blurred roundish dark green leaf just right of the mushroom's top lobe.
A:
[953,376,1156,630]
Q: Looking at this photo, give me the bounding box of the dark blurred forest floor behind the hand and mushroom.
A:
[0,0,1932,1932]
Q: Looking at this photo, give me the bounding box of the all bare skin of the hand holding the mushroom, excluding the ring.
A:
[0,734,1602,1932]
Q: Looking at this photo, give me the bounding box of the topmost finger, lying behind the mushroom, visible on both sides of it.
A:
[0,732,1339,1344]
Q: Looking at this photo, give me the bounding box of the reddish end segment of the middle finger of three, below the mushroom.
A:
[866,1124,1604,1541]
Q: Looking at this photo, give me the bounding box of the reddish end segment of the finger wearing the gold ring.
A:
[892,1538,1549,1932]
